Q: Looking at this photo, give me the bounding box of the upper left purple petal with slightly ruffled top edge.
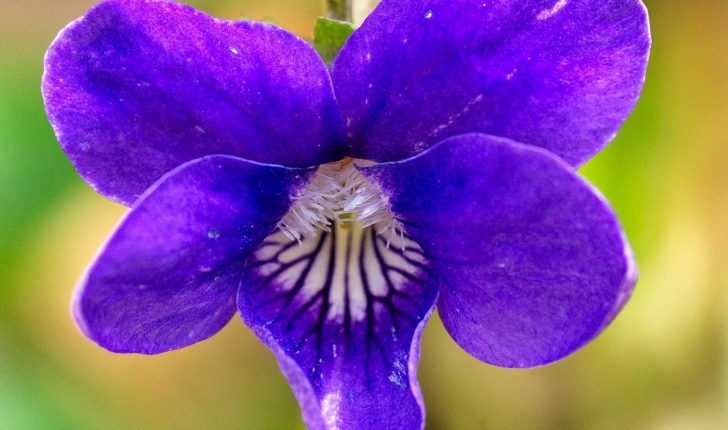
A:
[43,0,345,205]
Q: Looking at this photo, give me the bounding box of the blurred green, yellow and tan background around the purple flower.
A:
[0,0,728,430]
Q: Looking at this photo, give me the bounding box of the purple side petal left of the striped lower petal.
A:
[73,156,310,354]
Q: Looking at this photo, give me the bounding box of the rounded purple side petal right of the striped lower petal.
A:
[363,134,637,367]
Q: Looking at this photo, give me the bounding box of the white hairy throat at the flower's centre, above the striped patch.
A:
[278,157,404,246]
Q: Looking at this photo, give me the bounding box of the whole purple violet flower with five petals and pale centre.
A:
[43,0,650,430]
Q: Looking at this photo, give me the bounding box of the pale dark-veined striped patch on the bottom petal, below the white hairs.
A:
[248,222,432,322]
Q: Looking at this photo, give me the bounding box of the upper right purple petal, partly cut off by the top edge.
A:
[331,0,650,166]
